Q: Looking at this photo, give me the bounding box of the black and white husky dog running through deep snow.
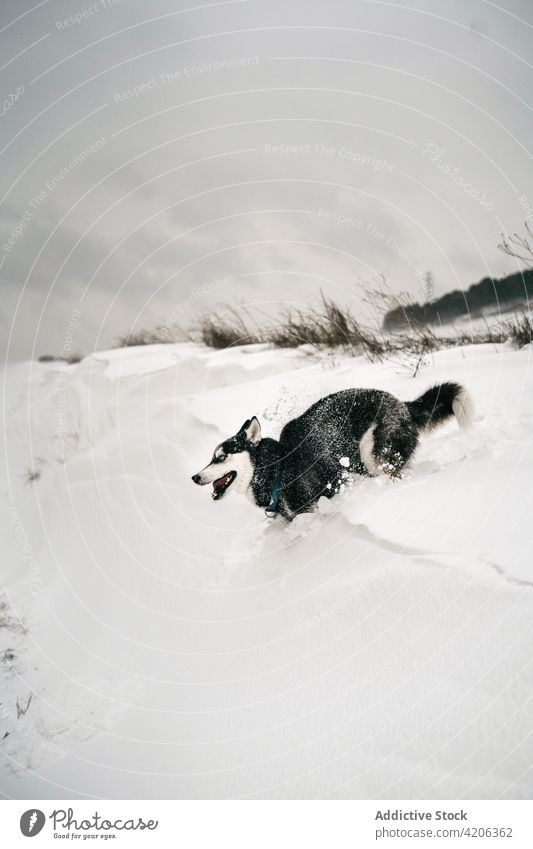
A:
[192,383,473,521]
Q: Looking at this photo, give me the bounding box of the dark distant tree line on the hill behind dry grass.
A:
[383,269,533,330]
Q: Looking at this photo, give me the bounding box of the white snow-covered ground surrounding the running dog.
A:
[0,338,533,799]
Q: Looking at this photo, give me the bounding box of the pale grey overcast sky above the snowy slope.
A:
[0,0,533,359]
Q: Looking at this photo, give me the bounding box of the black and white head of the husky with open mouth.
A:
[192,416,261,501]
